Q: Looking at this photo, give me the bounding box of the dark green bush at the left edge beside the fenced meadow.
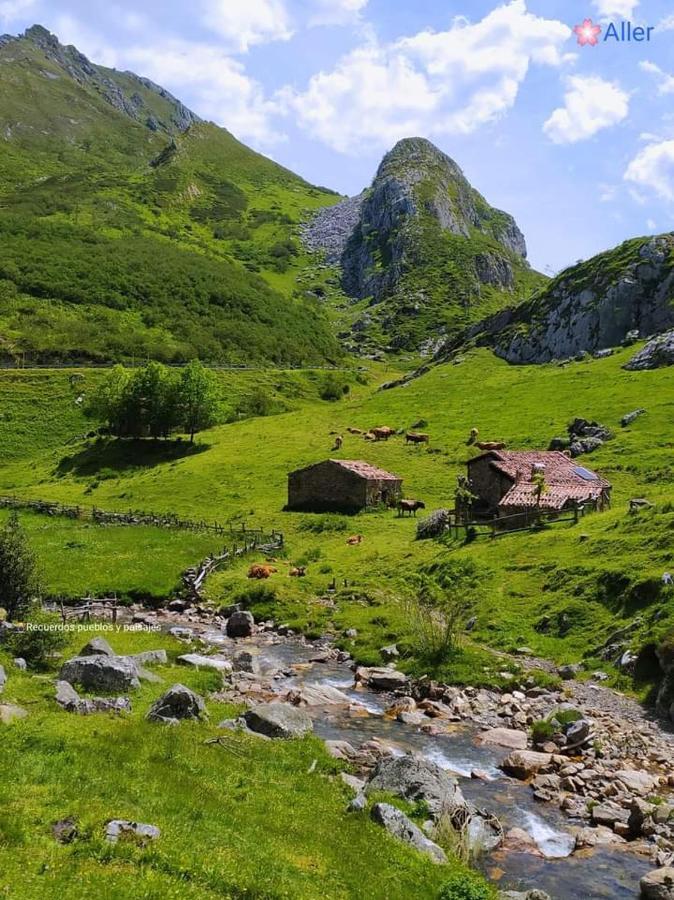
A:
[0,512,39,620]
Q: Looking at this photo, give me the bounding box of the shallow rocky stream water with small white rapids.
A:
[202,633,653,900]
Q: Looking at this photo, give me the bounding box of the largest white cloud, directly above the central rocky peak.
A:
[279,0,571,152]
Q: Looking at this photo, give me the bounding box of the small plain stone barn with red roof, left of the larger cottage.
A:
[286,459,403,512]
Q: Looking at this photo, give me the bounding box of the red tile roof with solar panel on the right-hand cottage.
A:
[469,450,611,509]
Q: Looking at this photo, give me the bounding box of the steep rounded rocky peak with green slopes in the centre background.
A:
[305,138,545,353]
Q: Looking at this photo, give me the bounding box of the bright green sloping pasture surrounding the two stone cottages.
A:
[0,350,674,680]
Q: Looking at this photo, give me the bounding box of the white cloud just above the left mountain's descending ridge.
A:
[123,40,283,146]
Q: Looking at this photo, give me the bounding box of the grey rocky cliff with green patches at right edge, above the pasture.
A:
[468,233,674,363]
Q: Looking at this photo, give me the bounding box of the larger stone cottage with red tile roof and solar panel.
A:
[467,450,611,524]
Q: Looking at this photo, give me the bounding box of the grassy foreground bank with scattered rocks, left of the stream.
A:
[0,633,472,900]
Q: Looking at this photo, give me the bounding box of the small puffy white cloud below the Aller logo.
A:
[543,75,629,144]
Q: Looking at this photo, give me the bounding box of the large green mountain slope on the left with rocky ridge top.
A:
[0,26,341,365]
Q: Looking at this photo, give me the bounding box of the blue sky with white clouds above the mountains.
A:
[0,0,674,271]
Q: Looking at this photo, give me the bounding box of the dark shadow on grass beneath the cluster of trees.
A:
[55,438,210,478]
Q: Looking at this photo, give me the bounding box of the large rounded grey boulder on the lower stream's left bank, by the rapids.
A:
[365,756,466,816]
